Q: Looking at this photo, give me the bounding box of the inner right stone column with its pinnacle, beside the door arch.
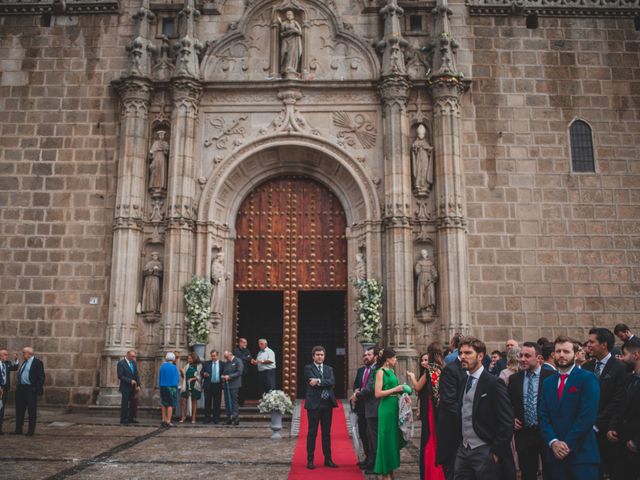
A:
[378,0,417,375]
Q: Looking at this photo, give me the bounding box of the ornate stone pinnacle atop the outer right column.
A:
[427,0,463,83]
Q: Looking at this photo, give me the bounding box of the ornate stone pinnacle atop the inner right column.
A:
[377,0,408,77]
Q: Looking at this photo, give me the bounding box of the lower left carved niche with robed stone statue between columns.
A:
[136,241,164,324]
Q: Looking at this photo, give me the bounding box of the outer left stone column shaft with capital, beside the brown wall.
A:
[97,77,152,405]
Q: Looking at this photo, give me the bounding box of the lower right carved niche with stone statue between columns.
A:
[413,239,439,323]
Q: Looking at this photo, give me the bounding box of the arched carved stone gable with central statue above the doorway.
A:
[201,0,380,82]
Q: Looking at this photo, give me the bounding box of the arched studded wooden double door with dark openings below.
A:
[234,176,348,398]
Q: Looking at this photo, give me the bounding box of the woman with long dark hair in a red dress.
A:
[407,342,444,480]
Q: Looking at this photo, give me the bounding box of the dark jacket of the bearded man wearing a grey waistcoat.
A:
[458,370,513,462]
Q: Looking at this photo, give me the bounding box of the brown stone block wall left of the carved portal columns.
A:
[0,15,130,405]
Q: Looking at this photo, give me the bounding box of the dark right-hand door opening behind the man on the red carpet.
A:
[298,291,347,398]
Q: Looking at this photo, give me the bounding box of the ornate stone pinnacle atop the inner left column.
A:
[173,0,204,79]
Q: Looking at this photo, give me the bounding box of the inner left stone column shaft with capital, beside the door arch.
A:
[162,77,202,350]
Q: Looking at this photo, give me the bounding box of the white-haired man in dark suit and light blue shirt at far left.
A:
[16,347,45,436]
